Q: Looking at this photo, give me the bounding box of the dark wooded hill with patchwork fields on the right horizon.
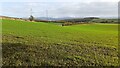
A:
[60,17,118,23]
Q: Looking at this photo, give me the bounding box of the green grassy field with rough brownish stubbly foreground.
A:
[2,19,118,66]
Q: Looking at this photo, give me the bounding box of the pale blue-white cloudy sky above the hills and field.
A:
[0,0,119,17]
